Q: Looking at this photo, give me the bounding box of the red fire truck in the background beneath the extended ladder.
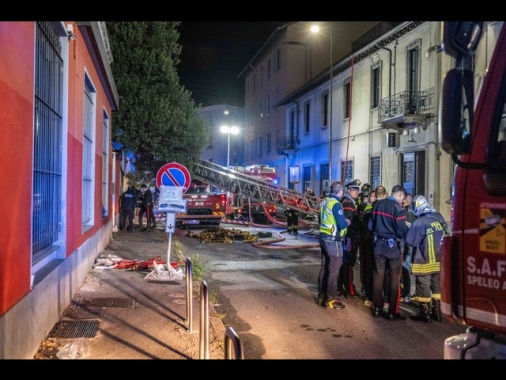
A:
[176,165,277,227]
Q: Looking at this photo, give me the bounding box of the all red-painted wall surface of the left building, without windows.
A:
[0,21,117,316]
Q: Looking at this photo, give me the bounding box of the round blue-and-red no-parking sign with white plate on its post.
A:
[156,162,191,270]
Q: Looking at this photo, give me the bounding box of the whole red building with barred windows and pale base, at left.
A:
[0,21,121,359]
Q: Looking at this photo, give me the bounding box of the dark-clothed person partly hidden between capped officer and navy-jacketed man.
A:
[358,190,376,307]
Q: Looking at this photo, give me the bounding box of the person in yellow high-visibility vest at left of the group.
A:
[318,181,350,309]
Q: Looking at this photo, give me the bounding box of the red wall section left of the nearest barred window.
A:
[0,22,35,315]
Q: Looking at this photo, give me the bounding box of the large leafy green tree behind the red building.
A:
[106,21,208,175]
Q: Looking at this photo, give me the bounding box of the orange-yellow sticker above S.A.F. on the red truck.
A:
[480,203,506,255]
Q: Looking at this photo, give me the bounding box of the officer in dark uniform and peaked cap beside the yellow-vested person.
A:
[338,179,361,298]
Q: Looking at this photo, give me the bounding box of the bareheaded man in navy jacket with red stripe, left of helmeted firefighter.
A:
[369,185,408,321]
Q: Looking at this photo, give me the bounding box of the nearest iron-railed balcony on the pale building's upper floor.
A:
[378,91,430,129]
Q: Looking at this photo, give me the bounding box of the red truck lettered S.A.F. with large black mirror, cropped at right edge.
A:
[439,21,506,359]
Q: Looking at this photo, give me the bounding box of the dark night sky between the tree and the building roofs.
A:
[178,21,288,107]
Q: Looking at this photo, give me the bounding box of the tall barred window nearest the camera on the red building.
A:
[32,22,63,263]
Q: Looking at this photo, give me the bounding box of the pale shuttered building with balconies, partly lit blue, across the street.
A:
[242,21,498,221]
